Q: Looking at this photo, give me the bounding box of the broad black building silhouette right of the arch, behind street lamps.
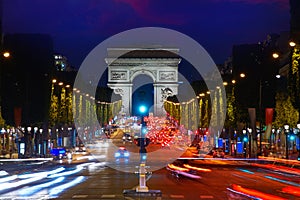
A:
[232,34,280,118]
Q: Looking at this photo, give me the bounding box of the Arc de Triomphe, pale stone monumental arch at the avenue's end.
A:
[105,48,181,116]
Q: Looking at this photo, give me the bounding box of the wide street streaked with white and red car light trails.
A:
[0,129,300,199]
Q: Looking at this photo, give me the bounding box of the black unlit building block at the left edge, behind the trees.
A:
[1,34,54,126]
